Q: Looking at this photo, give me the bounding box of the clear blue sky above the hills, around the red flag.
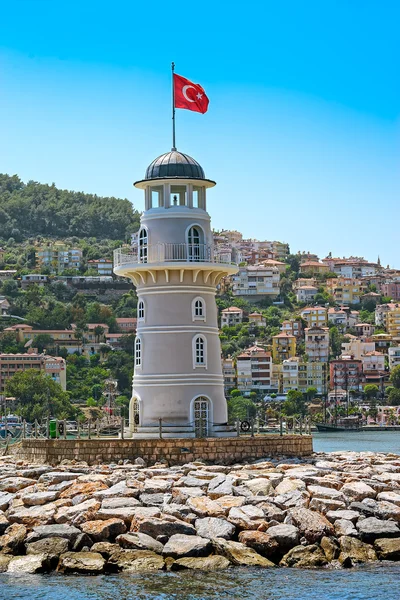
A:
[0,0,400,267]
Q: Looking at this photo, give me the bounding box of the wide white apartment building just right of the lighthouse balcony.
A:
[232,265,280,300]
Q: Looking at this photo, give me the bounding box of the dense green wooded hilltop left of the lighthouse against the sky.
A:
[0,173,139,242]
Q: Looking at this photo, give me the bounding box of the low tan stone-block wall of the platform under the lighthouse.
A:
[18,435,313,465]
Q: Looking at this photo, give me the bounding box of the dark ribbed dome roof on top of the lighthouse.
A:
[145,150,205,179]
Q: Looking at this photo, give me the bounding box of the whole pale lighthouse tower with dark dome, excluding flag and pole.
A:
[114,150,237,438]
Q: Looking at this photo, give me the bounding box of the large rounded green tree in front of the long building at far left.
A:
[5,369,75,421]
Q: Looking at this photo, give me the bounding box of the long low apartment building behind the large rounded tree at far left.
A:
[0,348,67,395]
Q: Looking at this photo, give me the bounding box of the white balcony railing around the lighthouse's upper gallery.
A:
[114,243,235,267]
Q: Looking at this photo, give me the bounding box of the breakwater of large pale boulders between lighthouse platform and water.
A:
[0,452,400,574]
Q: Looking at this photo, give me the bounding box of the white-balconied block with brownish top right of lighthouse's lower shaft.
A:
[236,346,272,393]
